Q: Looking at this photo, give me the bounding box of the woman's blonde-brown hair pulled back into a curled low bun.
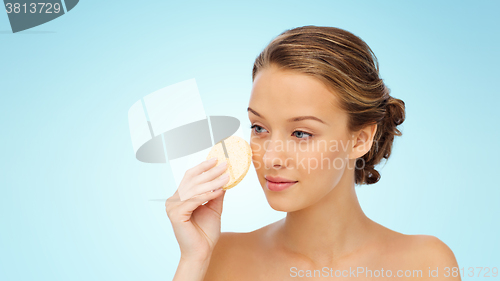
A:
[252,26,405,184]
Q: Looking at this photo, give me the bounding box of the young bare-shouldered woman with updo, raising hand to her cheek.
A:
[165,26,460,281]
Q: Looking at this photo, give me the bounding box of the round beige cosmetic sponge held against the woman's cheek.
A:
[207,136,252,190]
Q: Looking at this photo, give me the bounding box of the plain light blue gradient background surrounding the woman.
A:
[0,0,500,280]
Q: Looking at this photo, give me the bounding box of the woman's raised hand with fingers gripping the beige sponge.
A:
[165,159,229,261]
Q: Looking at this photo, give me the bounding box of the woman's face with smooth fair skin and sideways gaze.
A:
[248,66,353,212]
